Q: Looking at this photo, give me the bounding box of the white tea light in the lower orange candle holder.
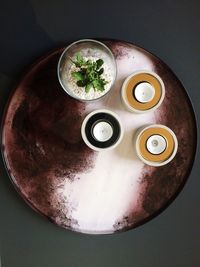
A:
[146,134,167,155]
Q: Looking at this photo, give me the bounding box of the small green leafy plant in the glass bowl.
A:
[71,53,108,93]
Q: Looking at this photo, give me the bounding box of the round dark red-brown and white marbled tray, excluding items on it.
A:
[2,41,196,234]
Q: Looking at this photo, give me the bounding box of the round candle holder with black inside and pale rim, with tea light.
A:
[81,109,124,151]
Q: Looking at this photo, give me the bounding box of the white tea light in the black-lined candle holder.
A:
[93,121,113,142]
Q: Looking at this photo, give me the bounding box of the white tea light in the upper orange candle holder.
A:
[134,82,155,103]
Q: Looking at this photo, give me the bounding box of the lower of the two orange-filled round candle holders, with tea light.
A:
[134,124,178,167]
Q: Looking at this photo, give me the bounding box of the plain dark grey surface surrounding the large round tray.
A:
[0,0,200,267]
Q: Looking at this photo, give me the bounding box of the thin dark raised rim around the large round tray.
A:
[0,38,199,235]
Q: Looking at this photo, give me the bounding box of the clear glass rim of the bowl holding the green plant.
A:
[57,39,117,102]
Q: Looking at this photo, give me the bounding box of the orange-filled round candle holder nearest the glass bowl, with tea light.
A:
[121,70,165,113]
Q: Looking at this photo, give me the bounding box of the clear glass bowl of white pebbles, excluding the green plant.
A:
[57,39,117,101]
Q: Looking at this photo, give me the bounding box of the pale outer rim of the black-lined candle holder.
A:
[81,109,124,152]
